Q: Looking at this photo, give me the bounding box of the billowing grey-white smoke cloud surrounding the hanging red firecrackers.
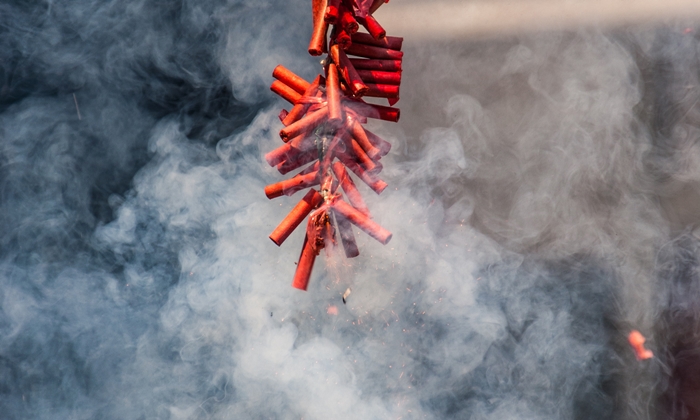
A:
[0,0,700,419]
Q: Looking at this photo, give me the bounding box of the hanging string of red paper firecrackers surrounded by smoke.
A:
[265,0,403,290]
